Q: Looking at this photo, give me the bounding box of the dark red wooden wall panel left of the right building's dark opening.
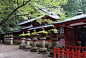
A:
[65,27,75,46]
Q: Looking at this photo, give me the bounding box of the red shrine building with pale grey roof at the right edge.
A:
[52,11,86,50]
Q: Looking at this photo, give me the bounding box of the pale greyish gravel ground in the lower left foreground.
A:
[0,43,52,58]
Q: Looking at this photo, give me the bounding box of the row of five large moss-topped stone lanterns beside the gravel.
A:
[20,29,58,55]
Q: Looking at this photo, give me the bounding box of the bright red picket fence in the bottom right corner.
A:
[54,48,86,58]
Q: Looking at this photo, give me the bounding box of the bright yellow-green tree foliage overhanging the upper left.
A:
[0,0,67,32]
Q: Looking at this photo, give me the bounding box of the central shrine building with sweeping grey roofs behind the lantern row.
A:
[18,8,60,41]
